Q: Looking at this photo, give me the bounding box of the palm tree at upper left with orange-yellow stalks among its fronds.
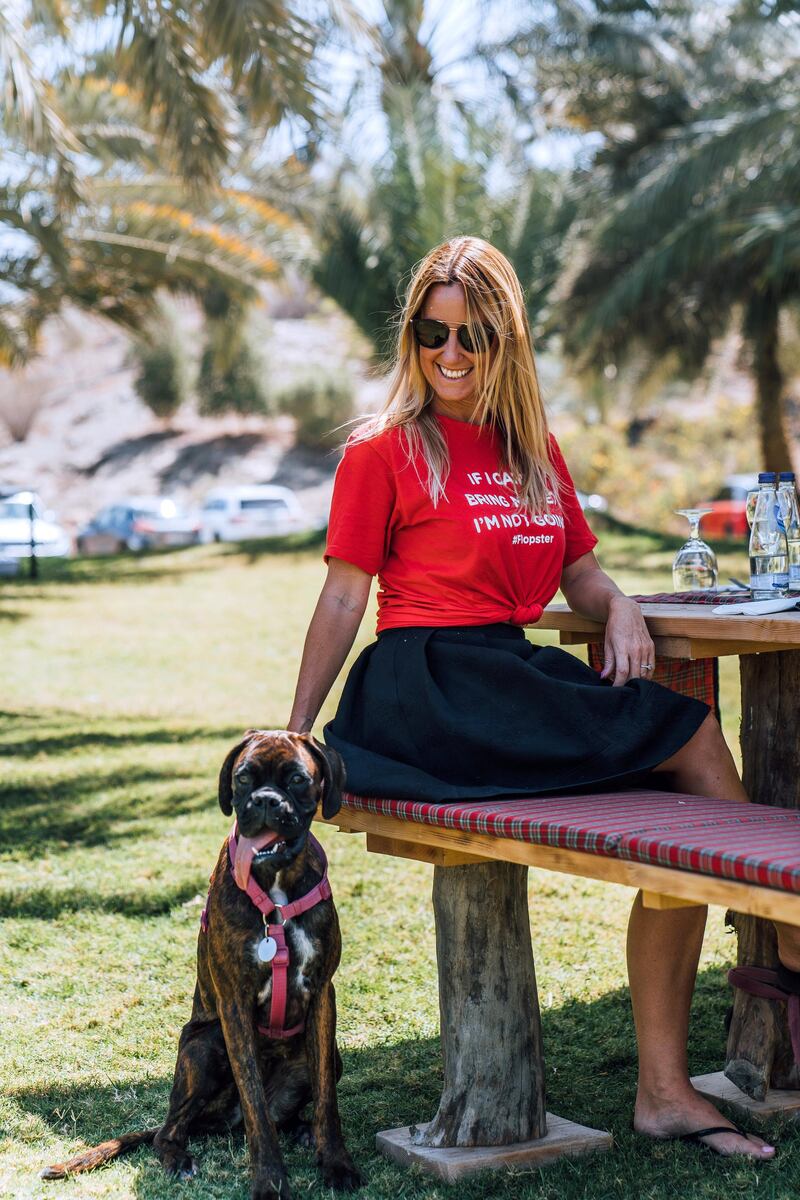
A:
[0,0,319,362]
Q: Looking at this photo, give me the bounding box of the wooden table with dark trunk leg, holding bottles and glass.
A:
[536,604,800,1100]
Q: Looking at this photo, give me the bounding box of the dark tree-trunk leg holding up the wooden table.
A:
[724,650,800,1100]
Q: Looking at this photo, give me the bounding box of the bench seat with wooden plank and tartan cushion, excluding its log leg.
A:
[323,791,800,925]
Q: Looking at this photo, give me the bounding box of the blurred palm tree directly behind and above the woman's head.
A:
[308,0,571,353]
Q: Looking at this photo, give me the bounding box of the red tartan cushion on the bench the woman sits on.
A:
[344,791,800,893]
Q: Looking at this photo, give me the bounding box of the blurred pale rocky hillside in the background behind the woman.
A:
[0,296,777,532]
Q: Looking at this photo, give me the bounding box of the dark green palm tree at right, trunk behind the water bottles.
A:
[494,4,800,469]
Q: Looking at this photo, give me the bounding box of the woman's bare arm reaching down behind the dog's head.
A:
[287,558,372,733]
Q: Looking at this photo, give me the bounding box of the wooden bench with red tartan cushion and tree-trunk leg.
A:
[319,791,800,1182]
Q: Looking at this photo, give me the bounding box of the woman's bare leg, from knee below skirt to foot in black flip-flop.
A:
[627,715,775,1158]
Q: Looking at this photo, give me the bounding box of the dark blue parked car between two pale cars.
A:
[76,496,200,554]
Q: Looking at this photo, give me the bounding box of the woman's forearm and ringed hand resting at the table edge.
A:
[561,552,656,688]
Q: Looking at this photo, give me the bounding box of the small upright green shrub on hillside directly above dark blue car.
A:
[131,301,190,420]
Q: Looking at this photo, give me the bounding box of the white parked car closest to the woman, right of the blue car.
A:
[200,484,314,541]
